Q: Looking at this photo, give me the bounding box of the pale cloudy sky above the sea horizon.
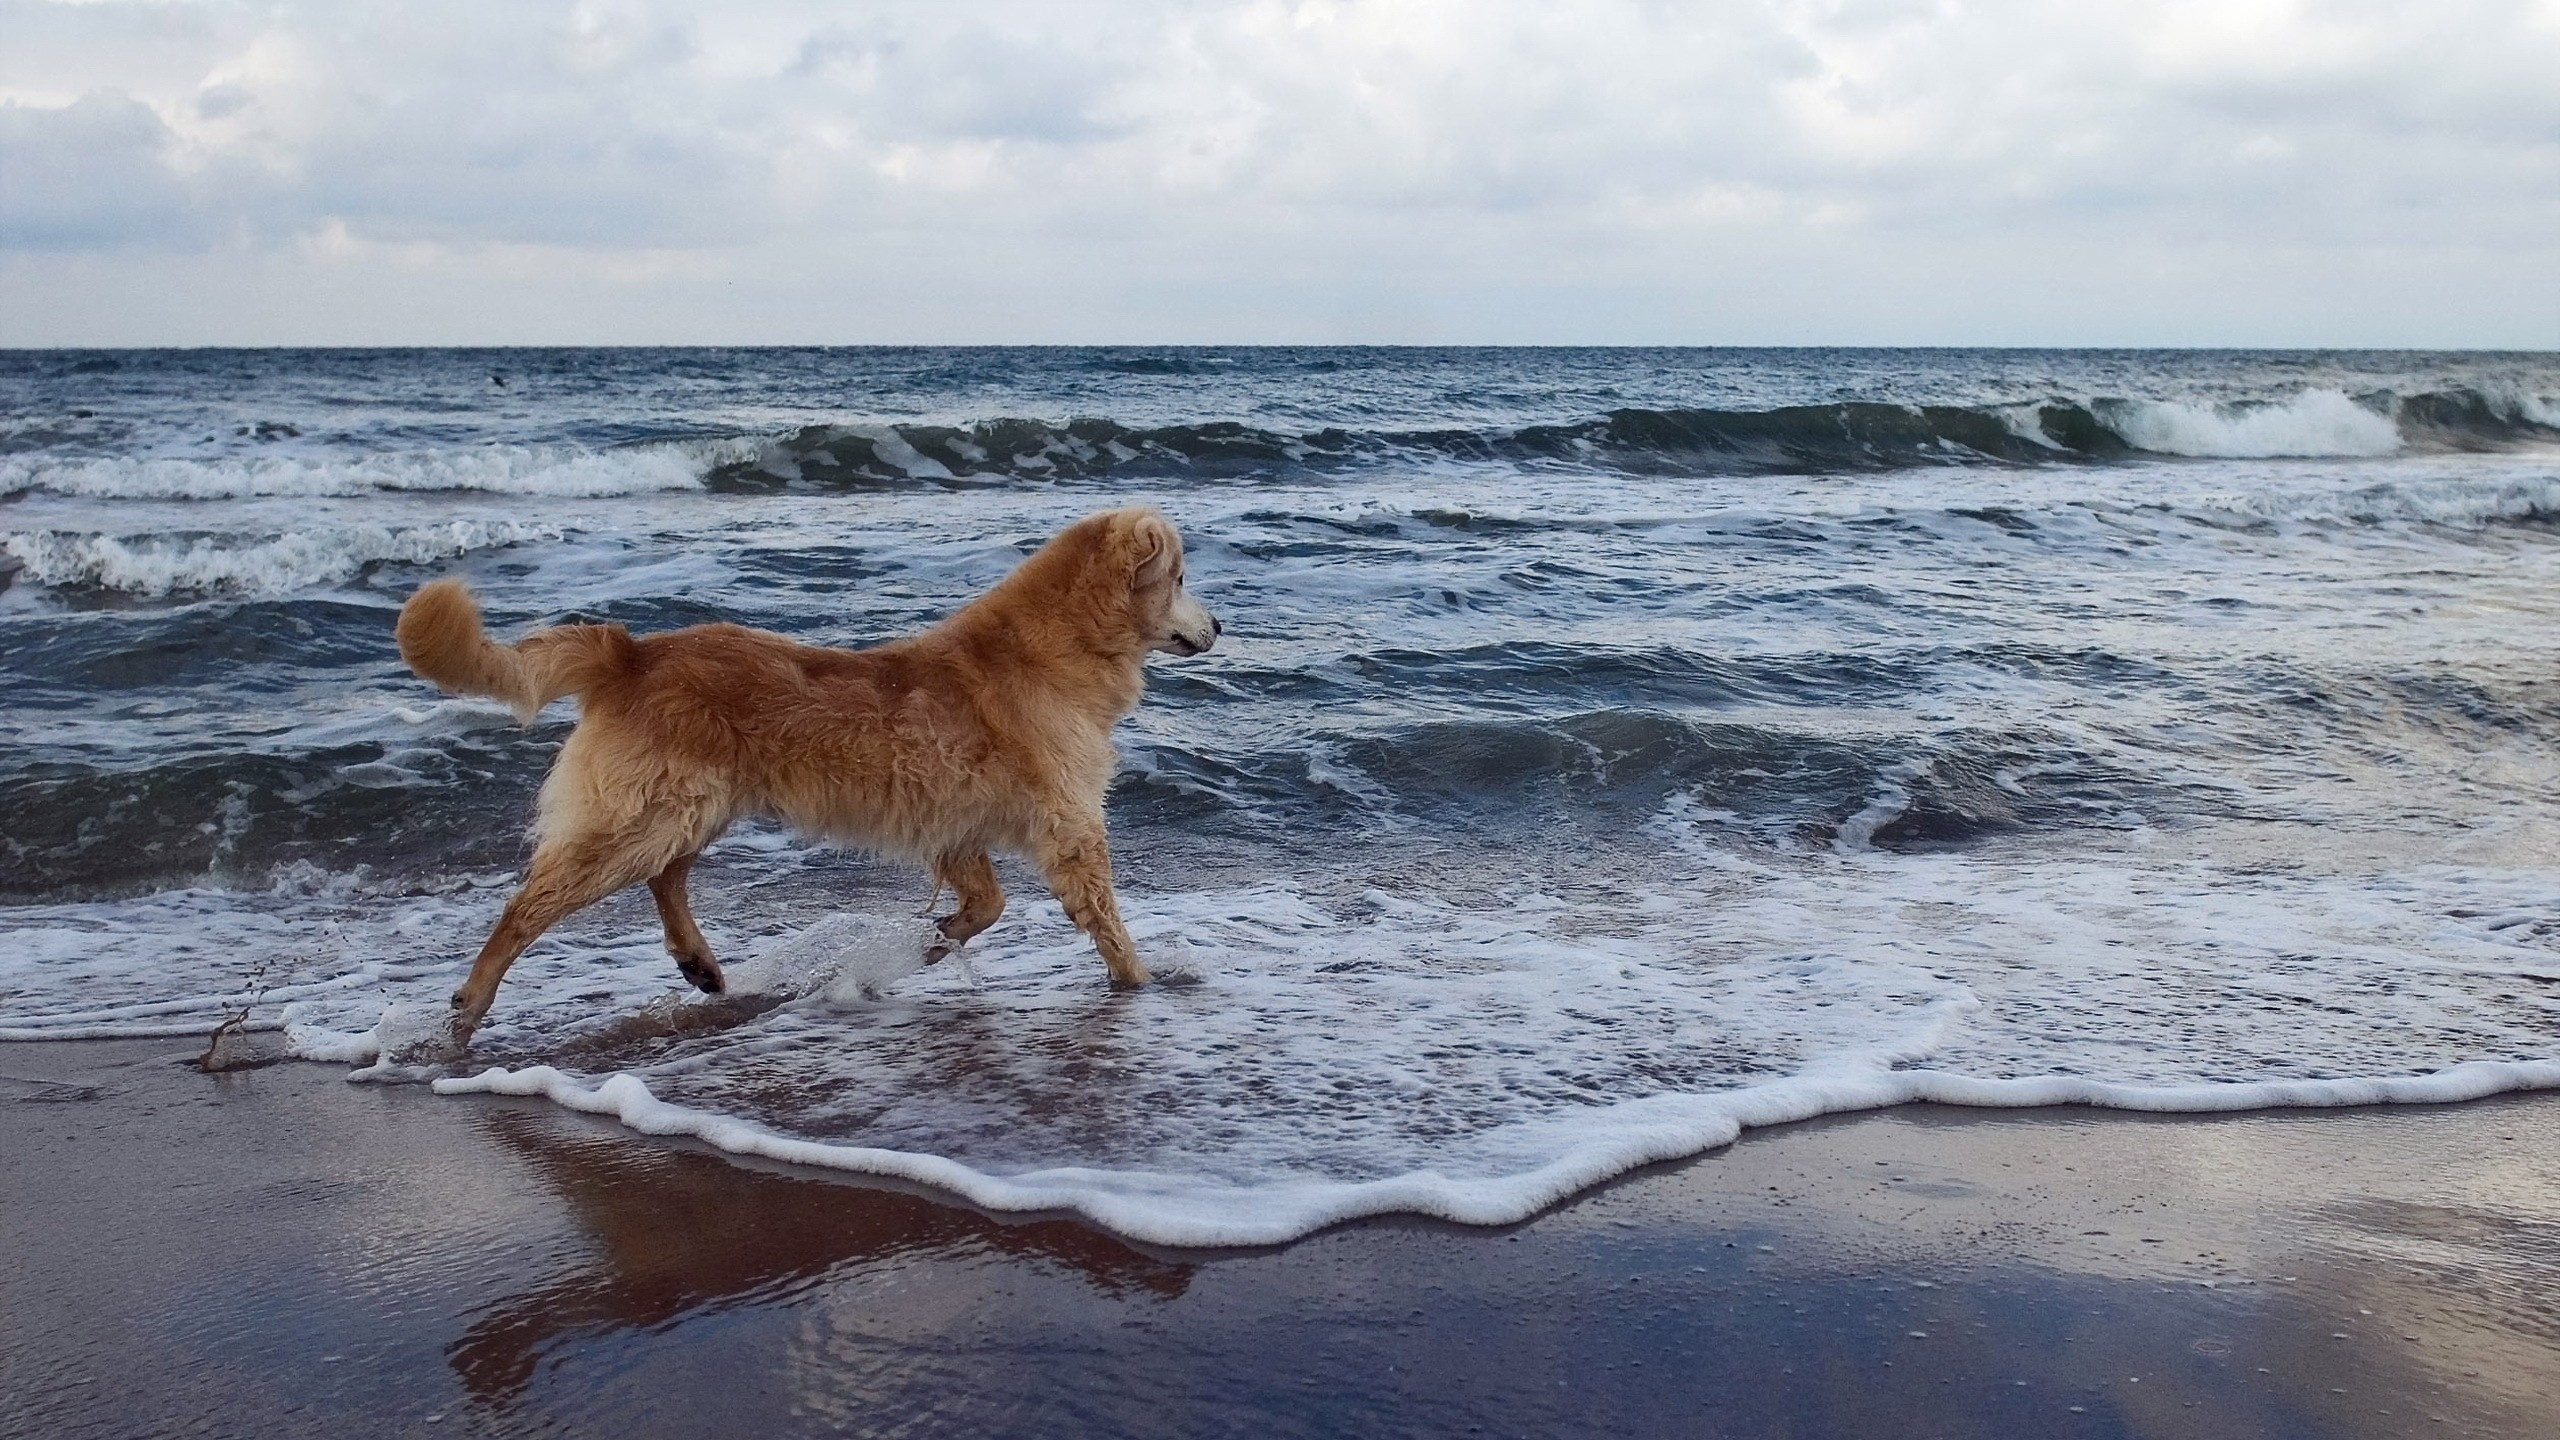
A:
[0,0,2560,348]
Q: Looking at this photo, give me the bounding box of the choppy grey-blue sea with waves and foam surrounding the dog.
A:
[0,346,2560,1245]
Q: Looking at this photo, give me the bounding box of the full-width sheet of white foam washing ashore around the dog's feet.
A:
[0,809,2560,1245]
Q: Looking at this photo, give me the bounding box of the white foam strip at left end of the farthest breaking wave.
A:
[0,441,740,500]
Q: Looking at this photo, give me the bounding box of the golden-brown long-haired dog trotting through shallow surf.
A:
[399,507,1221,1040]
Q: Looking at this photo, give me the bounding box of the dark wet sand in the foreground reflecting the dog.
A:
[0,1040,2560,1440]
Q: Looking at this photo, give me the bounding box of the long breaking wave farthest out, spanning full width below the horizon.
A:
[0,384,2560,500]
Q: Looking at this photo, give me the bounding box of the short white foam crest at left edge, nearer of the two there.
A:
[0,520,563,594]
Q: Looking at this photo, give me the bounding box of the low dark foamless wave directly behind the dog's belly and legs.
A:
[0,696,2140,899]
